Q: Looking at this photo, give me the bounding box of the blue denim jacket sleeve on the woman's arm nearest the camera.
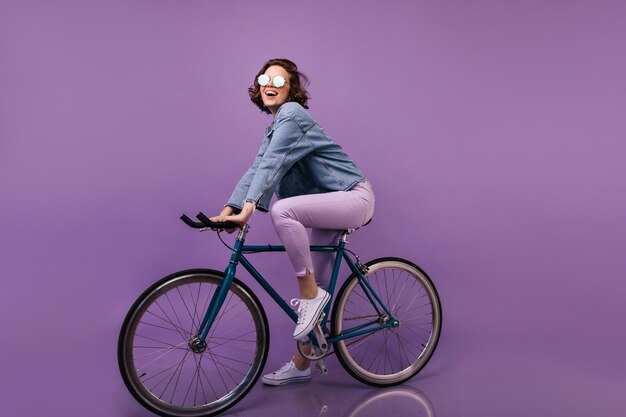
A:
[245,115,314,205]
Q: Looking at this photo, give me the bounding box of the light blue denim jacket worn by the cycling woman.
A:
[226,102,365,211]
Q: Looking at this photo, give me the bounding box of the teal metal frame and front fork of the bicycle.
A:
[196,224,400,345]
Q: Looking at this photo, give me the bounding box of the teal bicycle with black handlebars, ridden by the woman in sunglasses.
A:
[118,213,442,417]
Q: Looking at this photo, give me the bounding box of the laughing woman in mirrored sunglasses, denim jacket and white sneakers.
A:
[211,59,374,385]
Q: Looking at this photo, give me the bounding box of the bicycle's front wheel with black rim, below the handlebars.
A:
[118,269,269,417]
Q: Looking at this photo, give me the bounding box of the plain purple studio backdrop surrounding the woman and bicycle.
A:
[0,0,626,417]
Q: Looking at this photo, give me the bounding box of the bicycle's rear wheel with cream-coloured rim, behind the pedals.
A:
[331,258,442,386]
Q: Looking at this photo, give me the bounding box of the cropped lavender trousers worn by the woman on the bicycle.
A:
[270,181,375,287]
